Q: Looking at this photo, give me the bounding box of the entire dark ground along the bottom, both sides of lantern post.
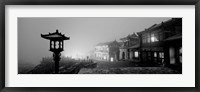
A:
[19,58,182,74]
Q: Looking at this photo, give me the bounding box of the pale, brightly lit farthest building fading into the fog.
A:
[94,40,120,62]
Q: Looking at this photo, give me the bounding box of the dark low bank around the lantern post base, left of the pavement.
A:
[19,58,96,74]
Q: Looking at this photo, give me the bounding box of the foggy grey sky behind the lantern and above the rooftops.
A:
[18,17,170,64]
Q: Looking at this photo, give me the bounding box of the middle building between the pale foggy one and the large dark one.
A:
[120,33,140,61]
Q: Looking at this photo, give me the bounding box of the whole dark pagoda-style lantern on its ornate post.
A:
[41,30,70,74]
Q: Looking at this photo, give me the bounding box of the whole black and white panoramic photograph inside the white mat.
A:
[17,17,182,74]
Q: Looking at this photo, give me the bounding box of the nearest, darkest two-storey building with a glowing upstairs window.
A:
[139,18,182,66]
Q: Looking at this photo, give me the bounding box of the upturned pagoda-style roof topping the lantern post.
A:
[41,29,70,40]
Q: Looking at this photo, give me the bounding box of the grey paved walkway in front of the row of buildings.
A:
[79,67,181,74]
